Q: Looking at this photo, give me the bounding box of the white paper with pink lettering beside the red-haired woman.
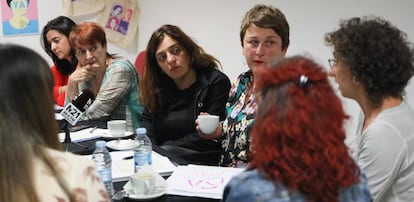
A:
[167,165,244,199]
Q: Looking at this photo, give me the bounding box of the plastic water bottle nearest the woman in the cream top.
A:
[92,140,114,198]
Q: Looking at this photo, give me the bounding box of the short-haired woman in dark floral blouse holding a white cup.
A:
[201,4,289,167]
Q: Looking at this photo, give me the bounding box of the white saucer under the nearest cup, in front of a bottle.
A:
[124,174,167,201]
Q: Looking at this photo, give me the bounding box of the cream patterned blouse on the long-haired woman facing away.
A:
[33,149,110,202]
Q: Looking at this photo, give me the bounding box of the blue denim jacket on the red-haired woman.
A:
[223,169,372,202]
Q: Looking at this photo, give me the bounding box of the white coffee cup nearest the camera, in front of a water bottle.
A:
[131,172,155,195]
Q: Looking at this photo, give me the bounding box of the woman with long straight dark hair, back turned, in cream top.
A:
[0,44,110,202]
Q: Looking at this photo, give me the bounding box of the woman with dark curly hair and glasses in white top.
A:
[325,17,414,201]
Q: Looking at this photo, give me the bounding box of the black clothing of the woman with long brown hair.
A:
[141,69,231,164]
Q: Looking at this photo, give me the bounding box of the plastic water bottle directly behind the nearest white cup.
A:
[134,128,152,172]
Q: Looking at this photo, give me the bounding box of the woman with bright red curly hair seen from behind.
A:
[223,56,371,202]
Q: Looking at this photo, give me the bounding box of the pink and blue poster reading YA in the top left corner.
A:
[1,0,39,36]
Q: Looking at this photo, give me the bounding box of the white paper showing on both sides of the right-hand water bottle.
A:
[88,150,176,182]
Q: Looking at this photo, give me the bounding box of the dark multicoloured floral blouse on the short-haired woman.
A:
[220,70,257,167]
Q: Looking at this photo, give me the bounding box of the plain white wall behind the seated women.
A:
[0,0,414,137]
